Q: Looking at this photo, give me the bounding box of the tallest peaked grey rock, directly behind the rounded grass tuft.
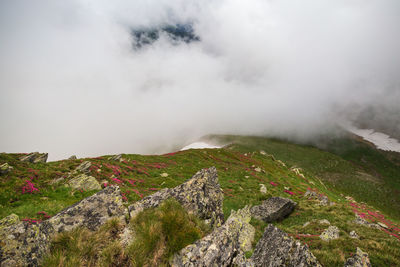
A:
[129,167,224,226]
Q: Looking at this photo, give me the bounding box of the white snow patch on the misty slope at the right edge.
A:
[348,127,400,152]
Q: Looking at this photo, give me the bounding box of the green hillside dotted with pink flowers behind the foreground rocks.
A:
[0,136,400,266]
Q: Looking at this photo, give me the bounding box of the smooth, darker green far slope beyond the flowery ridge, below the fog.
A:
[209,136,400,220]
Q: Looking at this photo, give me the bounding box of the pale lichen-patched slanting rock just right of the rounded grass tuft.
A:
[170,207,252,267]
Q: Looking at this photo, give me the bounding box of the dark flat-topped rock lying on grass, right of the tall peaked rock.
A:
[251,197,297,222]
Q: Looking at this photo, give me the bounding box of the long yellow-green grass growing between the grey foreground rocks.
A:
[43,200,210,267]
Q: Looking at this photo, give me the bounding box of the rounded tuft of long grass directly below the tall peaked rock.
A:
[128,199,208,266]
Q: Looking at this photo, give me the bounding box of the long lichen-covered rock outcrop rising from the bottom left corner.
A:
[0,186,126,266]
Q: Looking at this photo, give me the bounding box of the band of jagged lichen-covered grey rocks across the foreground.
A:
[0,167,370,266]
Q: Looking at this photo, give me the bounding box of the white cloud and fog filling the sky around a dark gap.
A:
[0,0,400,160]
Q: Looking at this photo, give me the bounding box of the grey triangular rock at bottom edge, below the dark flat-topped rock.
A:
[251,224,321,267]
